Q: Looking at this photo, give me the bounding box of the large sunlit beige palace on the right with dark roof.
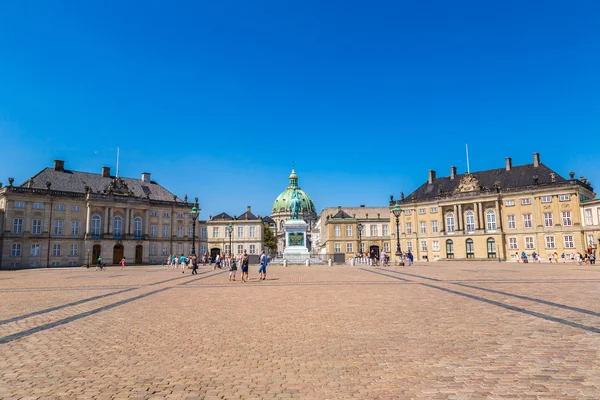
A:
[390,153,600,261]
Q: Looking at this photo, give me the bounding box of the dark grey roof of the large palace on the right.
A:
[406,163,567,200]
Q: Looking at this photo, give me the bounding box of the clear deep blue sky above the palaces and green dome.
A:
[0,0,600,219]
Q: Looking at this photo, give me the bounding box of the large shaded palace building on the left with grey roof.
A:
[0,160,193,268]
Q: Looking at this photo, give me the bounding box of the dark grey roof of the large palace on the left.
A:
[20,168,181,201]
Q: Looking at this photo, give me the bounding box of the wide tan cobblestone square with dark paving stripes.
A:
[0,261,600,399]
